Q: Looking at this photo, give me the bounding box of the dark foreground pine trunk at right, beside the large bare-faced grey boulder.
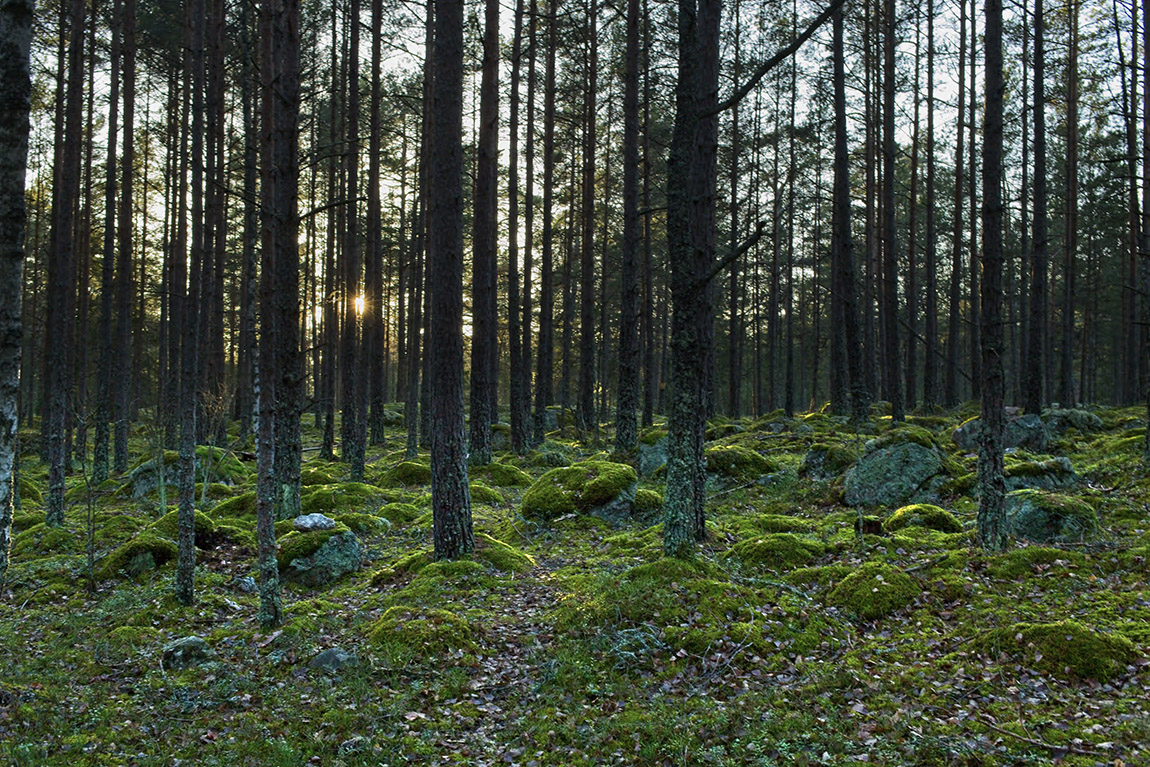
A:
[979,0,1007,551]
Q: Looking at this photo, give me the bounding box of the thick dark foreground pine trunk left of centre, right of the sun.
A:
[428,0,475,559]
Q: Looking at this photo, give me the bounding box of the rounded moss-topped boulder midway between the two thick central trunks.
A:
[523,461,638,524]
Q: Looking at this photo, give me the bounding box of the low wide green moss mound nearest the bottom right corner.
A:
[975,621,1135,681]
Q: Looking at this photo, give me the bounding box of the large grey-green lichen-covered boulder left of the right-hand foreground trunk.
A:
[843,440,943,506]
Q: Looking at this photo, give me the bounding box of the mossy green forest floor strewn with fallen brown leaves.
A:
[0,406,1150,767]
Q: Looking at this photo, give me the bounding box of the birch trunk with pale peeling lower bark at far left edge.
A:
[0,0,33,596]
